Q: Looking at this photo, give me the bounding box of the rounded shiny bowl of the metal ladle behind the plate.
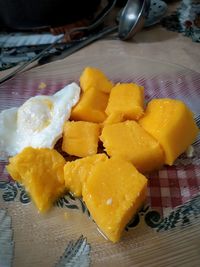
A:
[118,0,150,40]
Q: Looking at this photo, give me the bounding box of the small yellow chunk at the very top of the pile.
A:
[80,67,113,93]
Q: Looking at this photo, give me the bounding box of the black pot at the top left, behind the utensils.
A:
[0,0,100,30]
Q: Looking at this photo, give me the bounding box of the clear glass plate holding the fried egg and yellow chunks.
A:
[0,52,200,267]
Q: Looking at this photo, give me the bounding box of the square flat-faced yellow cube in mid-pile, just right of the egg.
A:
[62,121,100,157]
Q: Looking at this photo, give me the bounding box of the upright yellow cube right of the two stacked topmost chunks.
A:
[105,83,144,120]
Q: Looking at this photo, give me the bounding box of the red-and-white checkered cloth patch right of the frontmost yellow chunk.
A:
[148,158,200,215]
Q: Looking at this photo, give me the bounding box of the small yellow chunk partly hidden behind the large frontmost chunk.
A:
[64,153,108,197]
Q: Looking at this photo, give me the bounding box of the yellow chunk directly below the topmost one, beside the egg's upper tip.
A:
[70,87,109,122]
